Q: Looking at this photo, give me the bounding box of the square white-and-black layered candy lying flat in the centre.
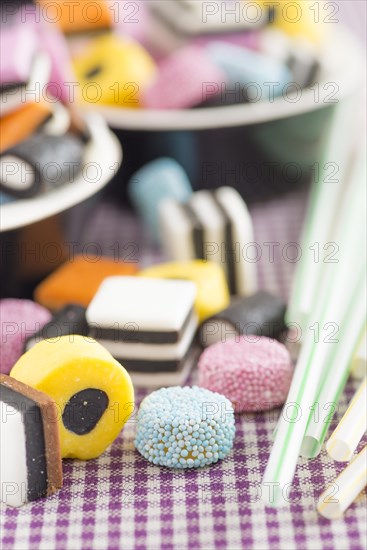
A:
[86,277,198,387]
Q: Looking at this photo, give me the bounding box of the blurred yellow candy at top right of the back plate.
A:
[257,0,335,45]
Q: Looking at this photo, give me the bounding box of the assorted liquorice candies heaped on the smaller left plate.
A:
[0,12,88,203]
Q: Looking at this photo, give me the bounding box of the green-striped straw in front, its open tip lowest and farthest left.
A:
[262,169,365,506]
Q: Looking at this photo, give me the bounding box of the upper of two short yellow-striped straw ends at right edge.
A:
[326,377,367,462]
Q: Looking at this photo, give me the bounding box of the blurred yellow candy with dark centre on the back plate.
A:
[73,33,157,108]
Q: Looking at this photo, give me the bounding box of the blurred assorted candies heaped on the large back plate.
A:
[58,0,325,109]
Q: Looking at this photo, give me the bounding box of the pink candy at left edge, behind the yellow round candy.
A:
[0,298,51,374]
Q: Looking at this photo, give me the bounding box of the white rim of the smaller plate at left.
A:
[0,115,122,232]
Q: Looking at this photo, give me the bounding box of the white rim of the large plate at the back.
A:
[87,26,364,131]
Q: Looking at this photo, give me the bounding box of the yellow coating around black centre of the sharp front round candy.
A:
[10,335,134,460]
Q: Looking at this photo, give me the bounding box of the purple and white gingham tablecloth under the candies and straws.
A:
[1,191,367,550]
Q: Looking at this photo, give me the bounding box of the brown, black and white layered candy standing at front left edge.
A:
[0,374,62,506]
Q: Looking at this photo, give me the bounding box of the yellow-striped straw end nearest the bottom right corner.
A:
[317,446,367,519]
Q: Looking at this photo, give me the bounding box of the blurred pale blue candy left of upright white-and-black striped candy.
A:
[128,158,192,246]
